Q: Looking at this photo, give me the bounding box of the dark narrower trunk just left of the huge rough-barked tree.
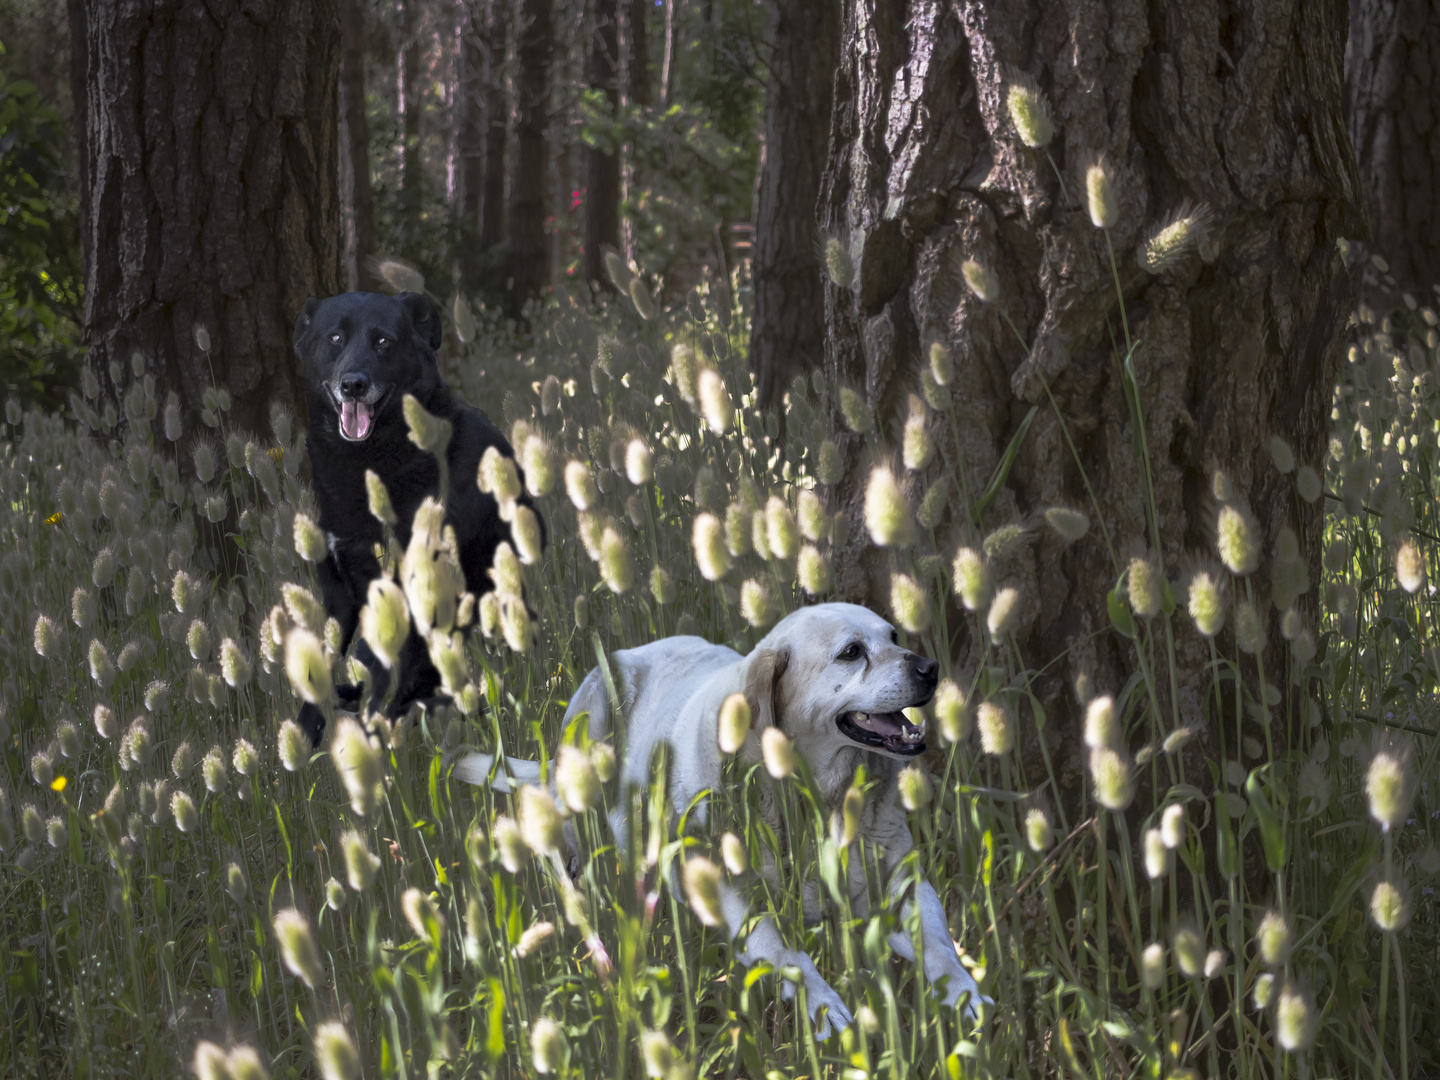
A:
[750,0,840,409]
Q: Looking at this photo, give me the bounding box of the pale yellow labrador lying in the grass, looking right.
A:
[455,603,989,1038]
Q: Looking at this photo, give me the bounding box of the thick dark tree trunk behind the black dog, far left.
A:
[71,0,340,443]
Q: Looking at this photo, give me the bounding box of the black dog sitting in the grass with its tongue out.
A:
[295,292,543,744]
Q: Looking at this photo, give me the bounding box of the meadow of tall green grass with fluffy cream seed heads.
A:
[0,239,1440,1080]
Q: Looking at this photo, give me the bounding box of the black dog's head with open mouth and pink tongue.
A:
[294,292,444,442]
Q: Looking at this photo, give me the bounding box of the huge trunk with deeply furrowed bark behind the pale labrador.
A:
[819,0,1364,802]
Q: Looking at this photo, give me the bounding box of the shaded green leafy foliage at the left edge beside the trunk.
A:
[0,45,81,406]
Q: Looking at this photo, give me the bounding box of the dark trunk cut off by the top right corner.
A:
[1346,0,1440,292]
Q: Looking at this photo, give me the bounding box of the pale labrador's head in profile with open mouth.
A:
[746,603,939,770]
